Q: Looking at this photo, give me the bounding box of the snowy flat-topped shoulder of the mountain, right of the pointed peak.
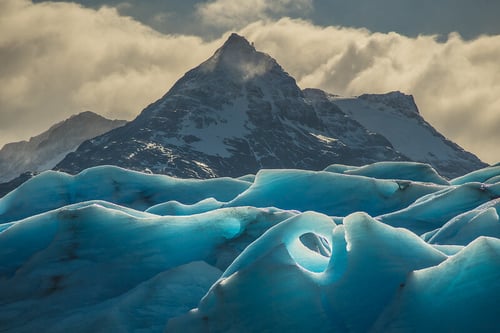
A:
[329,92,481,177]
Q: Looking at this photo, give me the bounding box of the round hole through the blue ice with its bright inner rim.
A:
[288,232,332,273]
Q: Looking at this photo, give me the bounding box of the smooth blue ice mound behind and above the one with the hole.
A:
[227,170,445,216]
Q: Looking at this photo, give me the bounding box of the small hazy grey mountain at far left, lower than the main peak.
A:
[0,111,126,182]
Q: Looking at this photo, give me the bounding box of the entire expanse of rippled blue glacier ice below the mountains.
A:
[0,162,500,332]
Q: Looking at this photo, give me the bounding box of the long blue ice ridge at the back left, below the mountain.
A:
[0,166,251,223]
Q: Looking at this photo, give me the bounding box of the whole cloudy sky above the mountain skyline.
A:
[0,0,500,163]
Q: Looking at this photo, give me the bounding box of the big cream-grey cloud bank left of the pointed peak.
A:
[0,0,220,145]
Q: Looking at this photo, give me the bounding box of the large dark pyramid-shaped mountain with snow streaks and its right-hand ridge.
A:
[56,34,485,178]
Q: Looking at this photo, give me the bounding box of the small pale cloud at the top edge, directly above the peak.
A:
[197,0,313,29]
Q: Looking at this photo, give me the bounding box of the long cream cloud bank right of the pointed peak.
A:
[241,18,500,163]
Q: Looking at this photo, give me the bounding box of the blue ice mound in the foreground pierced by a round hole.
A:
[168,213,447,332]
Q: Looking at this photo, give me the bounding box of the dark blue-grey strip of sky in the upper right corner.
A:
[311,0,500,39]
